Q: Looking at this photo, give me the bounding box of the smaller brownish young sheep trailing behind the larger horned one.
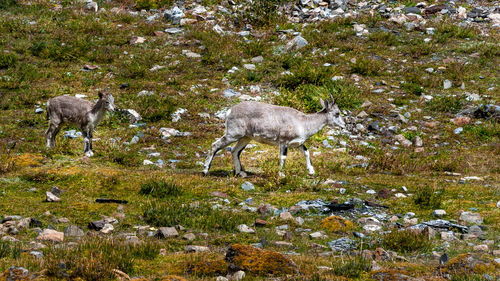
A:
[45,92,115,157]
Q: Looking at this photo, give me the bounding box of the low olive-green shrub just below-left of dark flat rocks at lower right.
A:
[381,230,432,254]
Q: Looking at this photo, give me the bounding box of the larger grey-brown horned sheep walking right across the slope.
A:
[203,95,345,177]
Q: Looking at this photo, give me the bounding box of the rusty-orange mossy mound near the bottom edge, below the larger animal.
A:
[226,244,298,275]
